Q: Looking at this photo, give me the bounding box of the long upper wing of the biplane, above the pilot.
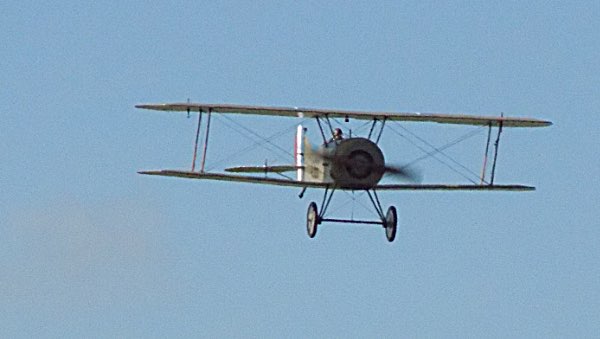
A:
[135,103,552,127]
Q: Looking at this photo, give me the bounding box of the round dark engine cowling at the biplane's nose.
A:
[330,138,385,189]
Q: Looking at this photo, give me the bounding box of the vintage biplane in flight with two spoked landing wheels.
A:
[135,102,552,242]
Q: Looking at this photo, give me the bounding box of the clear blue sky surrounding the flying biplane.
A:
[0,1,600,338]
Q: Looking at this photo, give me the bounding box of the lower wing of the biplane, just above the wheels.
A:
[139,170,535,191]
